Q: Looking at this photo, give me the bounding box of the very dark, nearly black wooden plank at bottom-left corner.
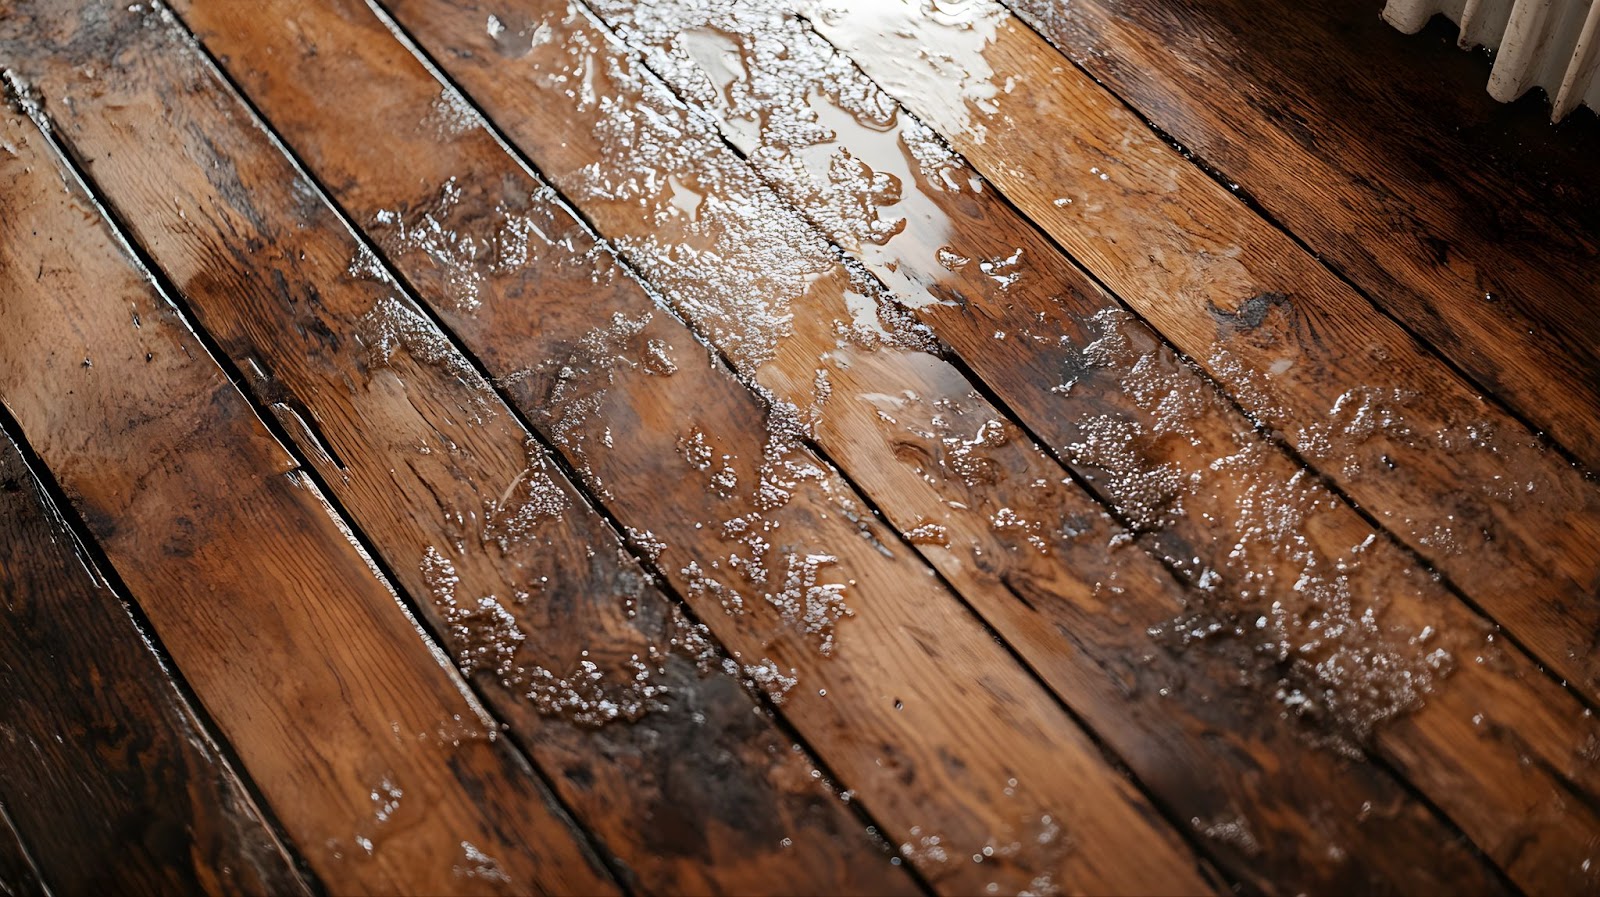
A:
[0,429,309,894]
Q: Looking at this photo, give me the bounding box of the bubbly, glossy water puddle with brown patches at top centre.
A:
[602,0,981,307]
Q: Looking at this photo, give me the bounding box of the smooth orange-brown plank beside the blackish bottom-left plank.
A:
[0,80,611,892]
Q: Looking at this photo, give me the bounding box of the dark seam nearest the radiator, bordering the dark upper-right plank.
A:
[998,0,1600,481]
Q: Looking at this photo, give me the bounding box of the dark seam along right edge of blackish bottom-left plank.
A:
[0,393,328,897]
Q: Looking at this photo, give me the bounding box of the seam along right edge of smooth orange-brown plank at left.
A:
[8,76,634,895]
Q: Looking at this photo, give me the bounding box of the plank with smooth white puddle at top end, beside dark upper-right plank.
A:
[800,3,1600,713]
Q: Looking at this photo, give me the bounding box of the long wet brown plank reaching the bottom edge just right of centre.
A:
[147,6,1222,889]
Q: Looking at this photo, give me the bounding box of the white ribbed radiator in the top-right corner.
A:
[1384,0,1600,122]
